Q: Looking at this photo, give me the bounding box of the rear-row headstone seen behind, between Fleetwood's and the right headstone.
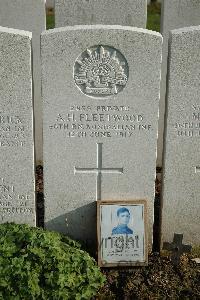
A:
[157,0,200,166]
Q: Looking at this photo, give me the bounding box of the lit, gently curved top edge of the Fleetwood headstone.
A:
[41,24,162,38]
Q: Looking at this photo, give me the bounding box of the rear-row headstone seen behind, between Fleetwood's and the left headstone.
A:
[0,0,46,161]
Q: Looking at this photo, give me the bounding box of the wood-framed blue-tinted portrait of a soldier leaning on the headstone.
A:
[97,200,148,267]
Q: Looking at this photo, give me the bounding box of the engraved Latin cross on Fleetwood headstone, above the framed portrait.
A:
[74,143,123,200]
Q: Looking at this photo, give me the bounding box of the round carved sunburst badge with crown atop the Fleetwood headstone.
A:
[74,46,128,98]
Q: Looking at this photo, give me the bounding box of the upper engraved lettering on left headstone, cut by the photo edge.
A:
[0,112,26,148]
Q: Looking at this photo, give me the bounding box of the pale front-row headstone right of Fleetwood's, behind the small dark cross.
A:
[162,26,200,244]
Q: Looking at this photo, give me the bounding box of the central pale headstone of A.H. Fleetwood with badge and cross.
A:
[41,25,162,244]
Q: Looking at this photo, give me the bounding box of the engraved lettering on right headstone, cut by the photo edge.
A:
[174,104,200,138]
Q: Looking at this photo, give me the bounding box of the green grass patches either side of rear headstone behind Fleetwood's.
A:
[47,3,161,32]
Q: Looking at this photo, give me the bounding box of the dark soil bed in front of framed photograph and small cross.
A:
[96,254,200,300]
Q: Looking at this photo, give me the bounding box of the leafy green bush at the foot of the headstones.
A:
[0,224,105,300]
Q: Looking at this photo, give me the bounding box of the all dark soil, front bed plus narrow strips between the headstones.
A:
[36,166,200,300]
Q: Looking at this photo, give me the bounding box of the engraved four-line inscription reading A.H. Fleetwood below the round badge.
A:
[49,105,153,138]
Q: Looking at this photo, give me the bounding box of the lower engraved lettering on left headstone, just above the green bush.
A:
[0,178,34,221]
